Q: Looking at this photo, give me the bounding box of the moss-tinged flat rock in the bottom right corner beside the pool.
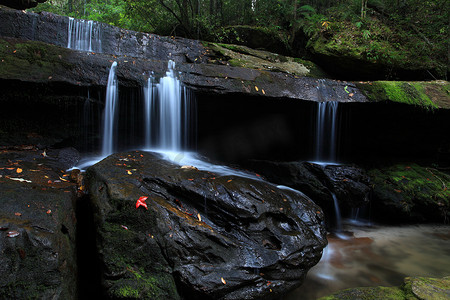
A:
[319,277,450,300]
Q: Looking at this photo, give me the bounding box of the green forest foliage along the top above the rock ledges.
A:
[29,0,450,78]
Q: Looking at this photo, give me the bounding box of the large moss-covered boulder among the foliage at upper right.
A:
[305,17,448,80]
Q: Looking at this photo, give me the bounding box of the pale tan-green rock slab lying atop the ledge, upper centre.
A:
[205,43,328,78]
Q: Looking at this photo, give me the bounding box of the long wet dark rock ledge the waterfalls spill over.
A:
[0,8,367,102]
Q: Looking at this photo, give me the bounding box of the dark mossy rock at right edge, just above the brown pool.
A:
[368,164,450,222]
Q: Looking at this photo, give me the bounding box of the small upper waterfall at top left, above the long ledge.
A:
[67,17,102,52]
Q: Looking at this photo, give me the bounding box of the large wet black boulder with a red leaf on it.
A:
[87,151,326,299]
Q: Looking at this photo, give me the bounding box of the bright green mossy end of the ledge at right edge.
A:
[357,80,450,109]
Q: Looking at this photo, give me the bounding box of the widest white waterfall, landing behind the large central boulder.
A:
[144,60,195,151]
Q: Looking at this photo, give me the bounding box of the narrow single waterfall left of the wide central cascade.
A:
[102,62,119,157]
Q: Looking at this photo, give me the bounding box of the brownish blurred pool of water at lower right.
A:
[283,223,450,300]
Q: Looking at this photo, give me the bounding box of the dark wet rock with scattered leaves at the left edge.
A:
[0,150,77,299]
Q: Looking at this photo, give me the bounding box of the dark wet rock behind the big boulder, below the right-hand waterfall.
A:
[249,161,371,226]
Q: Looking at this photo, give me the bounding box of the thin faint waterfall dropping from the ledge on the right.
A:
[315,101,338,162]
